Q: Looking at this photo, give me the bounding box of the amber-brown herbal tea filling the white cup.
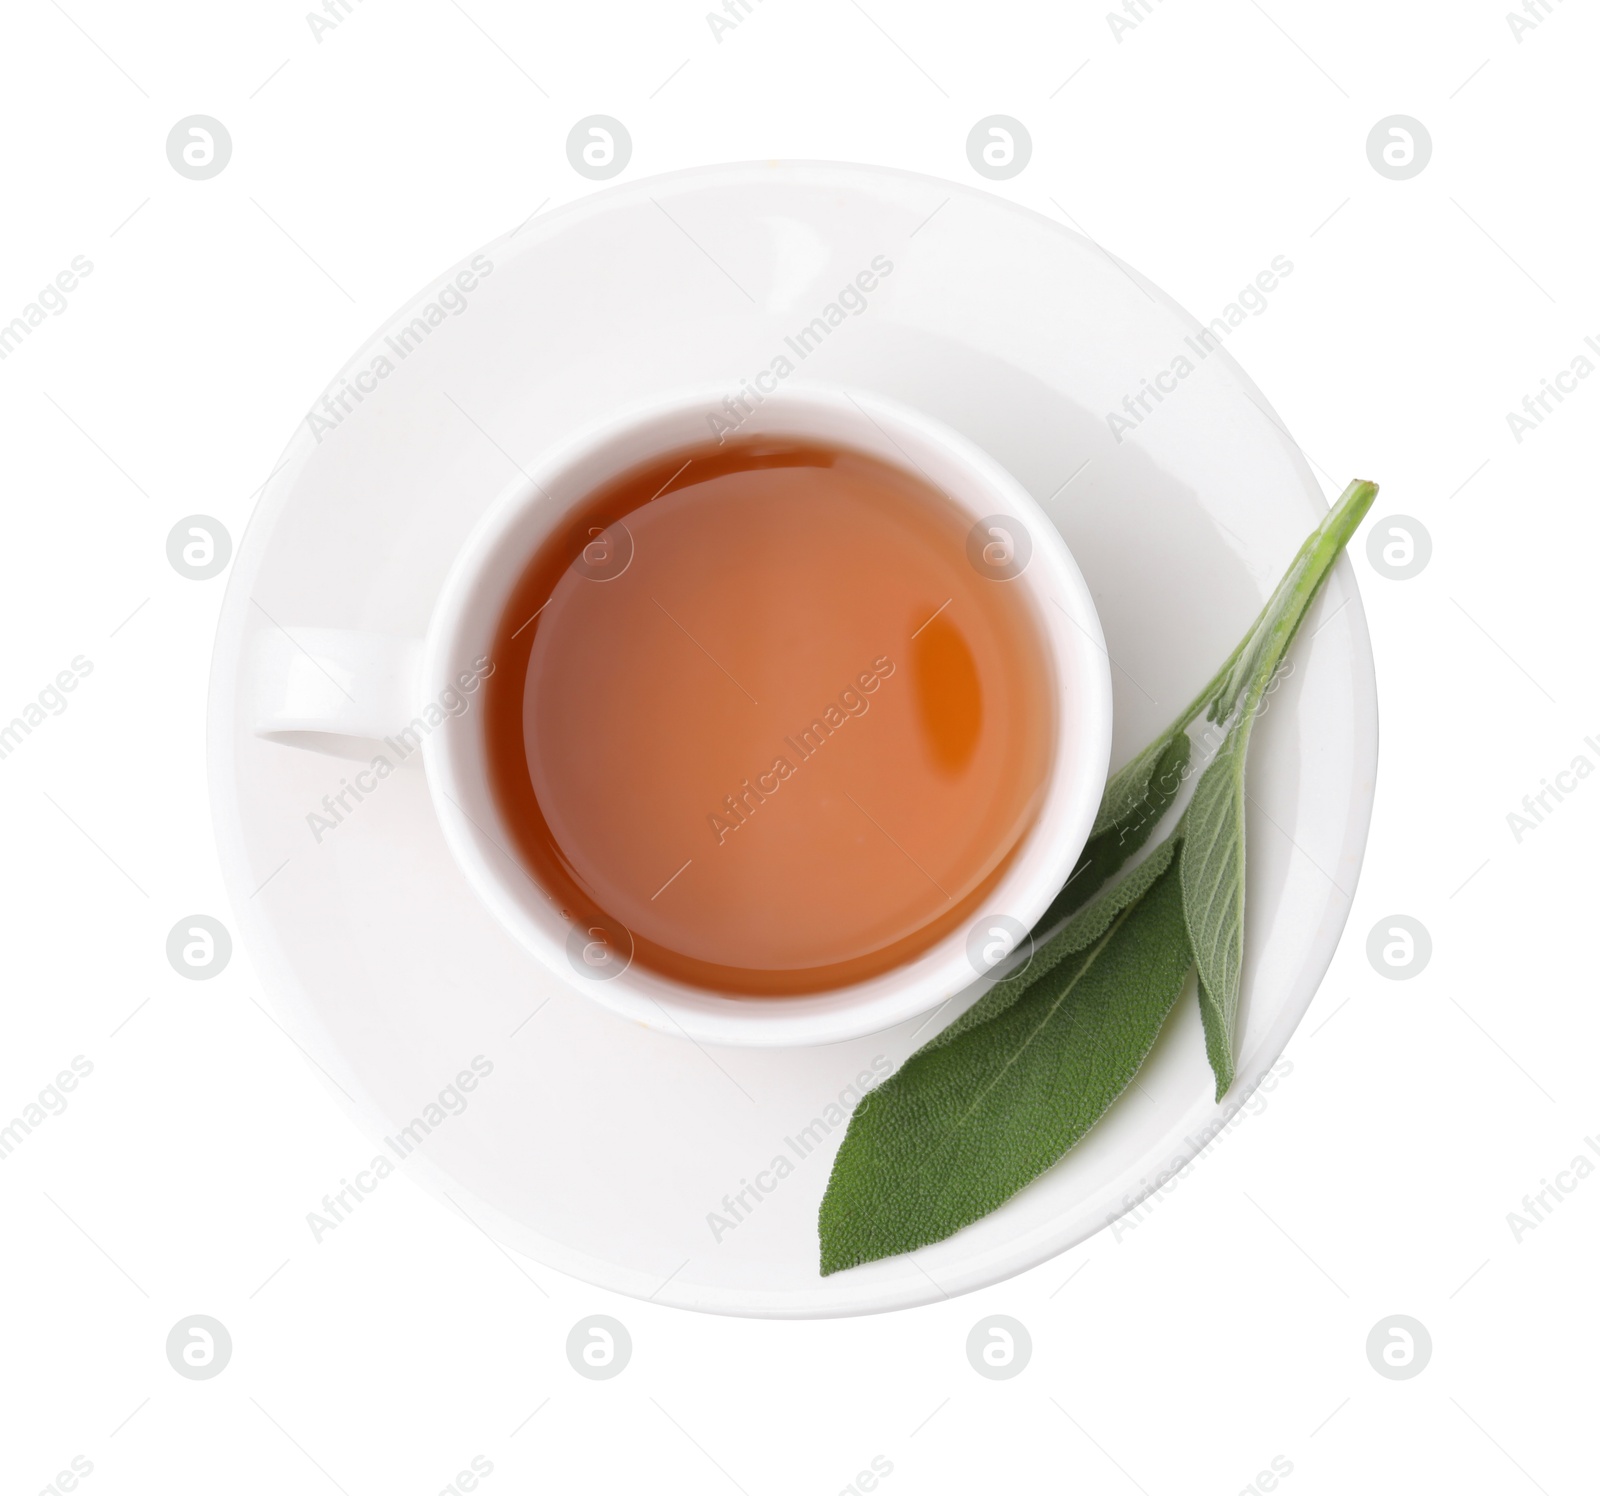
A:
[483,437,1070,995]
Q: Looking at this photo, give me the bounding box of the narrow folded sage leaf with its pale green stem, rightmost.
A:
[1181,483,1378,1101]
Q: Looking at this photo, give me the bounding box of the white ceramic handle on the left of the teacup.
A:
[251,627,422,757]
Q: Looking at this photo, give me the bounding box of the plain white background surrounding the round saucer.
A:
[0,0,1600,1496]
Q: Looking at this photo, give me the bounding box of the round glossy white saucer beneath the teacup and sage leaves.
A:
[210,165,1378,1317]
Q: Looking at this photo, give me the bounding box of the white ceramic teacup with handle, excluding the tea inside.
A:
[256,384,1112,1045]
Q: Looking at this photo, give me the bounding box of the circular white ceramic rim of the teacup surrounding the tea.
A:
[422,381,1112,1046]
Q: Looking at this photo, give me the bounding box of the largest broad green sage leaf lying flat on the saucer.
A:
[818,866,1192,1274]
